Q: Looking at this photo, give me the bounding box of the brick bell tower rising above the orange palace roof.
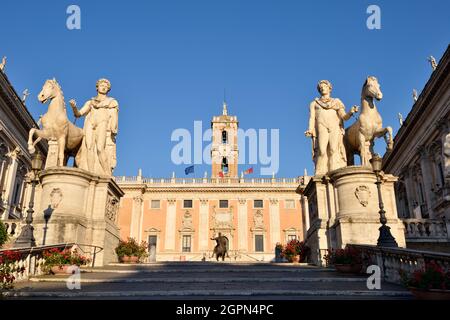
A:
[211,102,239,178]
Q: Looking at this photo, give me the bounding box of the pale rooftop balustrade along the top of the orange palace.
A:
[114,176,301,186]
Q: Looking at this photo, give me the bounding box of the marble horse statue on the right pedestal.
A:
[344,76,394,166]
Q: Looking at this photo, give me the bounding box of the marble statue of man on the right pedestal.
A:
[305,80,358,175]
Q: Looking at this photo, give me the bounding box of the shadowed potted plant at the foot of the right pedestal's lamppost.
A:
[324,246,362,273]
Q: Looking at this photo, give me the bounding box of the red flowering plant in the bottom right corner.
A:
[400,261,450,290]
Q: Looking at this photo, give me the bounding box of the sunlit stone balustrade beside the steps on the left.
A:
[0,243,75,281]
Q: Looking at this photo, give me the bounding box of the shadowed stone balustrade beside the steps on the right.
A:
[349,244,450,283]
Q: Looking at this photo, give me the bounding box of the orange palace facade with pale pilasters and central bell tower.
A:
[116,104,305,261]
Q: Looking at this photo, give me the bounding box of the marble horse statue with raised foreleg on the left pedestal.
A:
[28,78,83,166]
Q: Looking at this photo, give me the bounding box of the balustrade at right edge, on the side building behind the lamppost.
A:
[402,219,449,241]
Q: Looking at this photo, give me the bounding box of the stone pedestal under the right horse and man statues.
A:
[302,166,405,264]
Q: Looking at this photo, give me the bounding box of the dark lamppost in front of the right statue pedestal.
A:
[370,154,398,248]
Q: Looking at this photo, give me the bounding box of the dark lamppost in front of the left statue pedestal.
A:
[14,152,44,248]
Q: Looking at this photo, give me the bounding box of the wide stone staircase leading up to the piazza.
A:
[6,262,412,300]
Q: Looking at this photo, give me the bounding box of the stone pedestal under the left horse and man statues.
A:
[33,167,124,266]
